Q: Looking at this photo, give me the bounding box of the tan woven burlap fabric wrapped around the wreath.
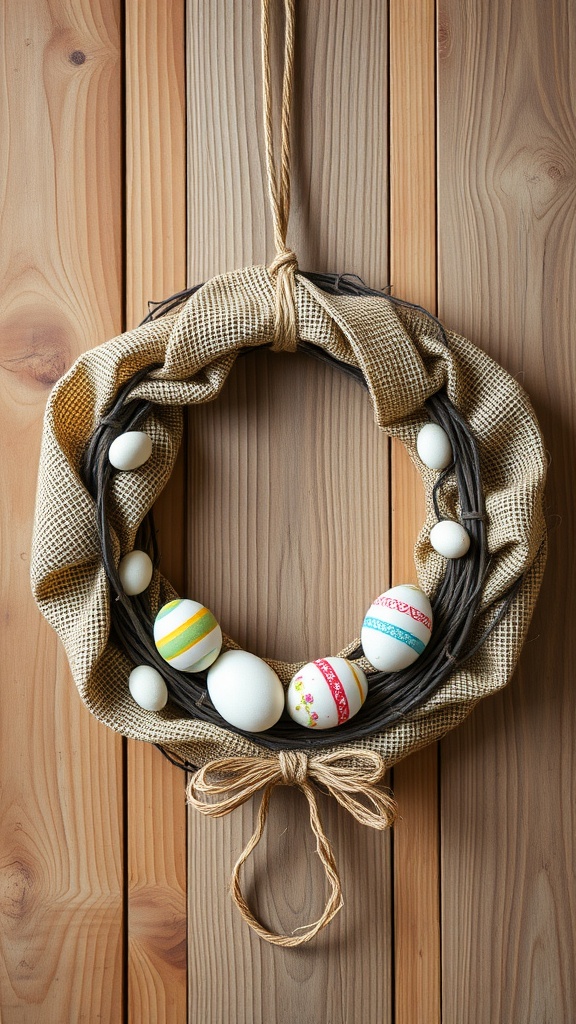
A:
[32,267,546,766]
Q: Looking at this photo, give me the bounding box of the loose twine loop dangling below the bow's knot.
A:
[230,781,343,949]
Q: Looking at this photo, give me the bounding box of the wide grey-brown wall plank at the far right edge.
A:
[439,0,576,1024]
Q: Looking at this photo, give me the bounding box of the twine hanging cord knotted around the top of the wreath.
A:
[261,0,298,352]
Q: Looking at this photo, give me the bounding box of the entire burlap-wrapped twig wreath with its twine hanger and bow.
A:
[32,0,545,945]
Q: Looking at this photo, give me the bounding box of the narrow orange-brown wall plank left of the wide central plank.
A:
[125,0,187,1024]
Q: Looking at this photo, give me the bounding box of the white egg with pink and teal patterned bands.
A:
[361,584,433,672]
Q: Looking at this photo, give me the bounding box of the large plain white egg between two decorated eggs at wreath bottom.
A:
[207,650,284,732]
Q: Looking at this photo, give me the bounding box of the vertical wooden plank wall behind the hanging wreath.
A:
[0,0,576,1024]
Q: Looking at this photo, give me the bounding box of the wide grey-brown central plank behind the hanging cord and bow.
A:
[189,0,392,1024]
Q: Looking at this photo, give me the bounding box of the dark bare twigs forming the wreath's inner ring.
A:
[82,273,522,751]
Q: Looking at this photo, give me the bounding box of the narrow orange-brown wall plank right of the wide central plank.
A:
[389,0,441,1024]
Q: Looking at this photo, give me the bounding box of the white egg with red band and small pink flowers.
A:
[286,657,368,729]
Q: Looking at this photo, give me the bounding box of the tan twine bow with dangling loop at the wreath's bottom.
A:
[187,748,397,947]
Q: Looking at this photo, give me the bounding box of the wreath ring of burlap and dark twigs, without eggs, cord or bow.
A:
[32,266,546,767]
